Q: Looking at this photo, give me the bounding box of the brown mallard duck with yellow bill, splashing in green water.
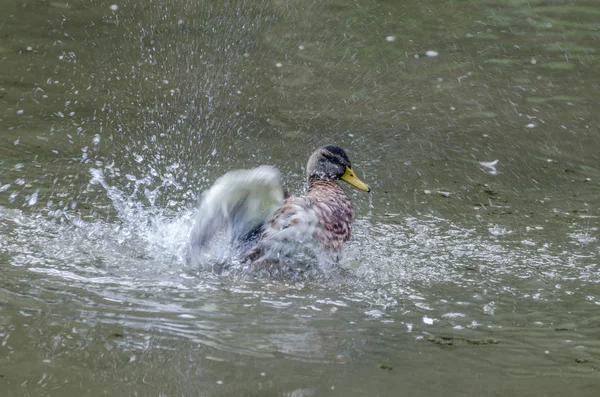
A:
[191,145,371,265]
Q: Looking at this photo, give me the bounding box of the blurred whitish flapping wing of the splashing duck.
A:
[190,166,284,252]
